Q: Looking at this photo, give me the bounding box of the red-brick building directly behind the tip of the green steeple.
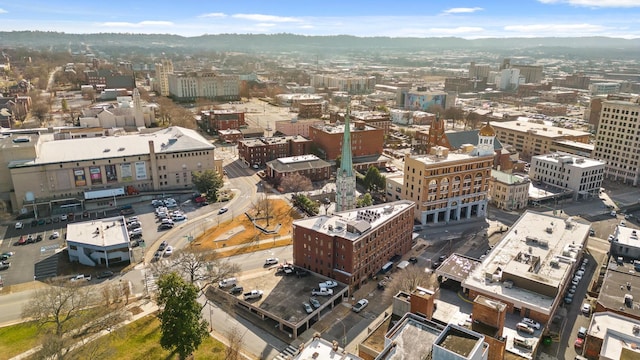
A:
[309,121,384,161]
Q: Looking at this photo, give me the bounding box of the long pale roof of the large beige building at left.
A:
[13,126,215,166]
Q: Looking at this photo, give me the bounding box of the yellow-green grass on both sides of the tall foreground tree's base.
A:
[70,315,225,360]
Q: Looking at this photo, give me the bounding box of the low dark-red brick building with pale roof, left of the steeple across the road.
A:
[238,136,312,166]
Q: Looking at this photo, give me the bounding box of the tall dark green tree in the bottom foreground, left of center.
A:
[158,272,208,359]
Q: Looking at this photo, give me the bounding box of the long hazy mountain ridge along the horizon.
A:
[0,31,640,58]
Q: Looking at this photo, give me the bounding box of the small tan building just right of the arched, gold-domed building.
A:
[489,170,531,210]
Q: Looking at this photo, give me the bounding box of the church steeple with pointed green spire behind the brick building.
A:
[336,106,356,211]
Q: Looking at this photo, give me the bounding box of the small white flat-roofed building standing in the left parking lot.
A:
[67,216,131,267]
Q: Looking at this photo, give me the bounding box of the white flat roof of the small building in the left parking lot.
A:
[67,216,129,247]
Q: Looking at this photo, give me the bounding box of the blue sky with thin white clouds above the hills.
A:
[0,0,640,39]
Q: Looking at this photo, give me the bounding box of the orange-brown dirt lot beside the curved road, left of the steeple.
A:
[194,199,298,256]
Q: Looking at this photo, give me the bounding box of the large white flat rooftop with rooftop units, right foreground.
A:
[463,211,590,314]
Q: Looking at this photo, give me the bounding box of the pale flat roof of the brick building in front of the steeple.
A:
[293,200,414,241]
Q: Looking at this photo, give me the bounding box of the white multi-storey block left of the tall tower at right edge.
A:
[529,153,605,200]
